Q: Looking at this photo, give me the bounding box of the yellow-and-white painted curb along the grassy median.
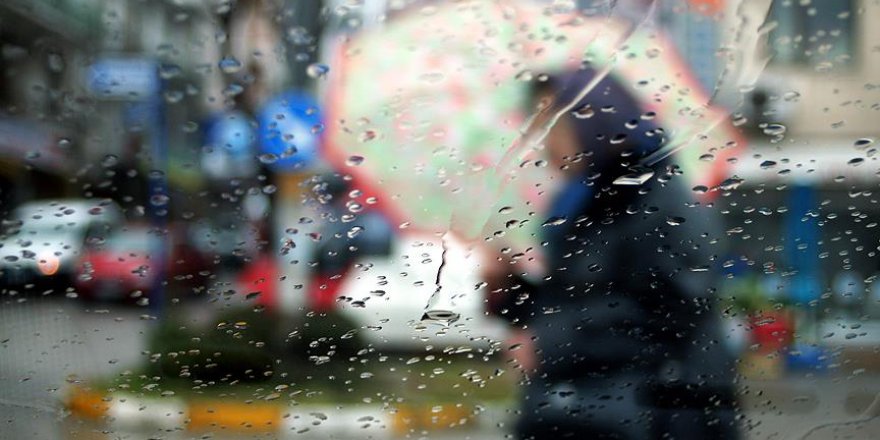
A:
[63,386,501,437]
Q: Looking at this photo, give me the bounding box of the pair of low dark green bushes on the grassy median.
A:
[148,309,364,381]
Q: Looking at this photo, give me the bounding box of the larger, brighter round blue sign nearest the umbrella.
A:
[257,92,324,171]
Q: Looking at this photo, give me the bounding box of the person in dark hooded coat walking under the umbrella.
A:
[487,69,738,439]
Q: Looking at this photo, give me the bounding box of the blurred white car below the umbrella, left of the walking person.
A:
[338,235,506,350]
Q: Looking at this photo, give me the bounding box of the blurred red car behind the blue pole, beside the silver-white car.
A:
[76,225,207,300]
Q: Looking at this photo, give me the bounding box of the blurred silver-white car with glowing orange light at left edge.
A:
[0,199,123,286]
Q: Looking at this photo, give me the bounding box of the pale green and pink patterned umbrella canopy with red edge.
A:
[325,1,735,258]
